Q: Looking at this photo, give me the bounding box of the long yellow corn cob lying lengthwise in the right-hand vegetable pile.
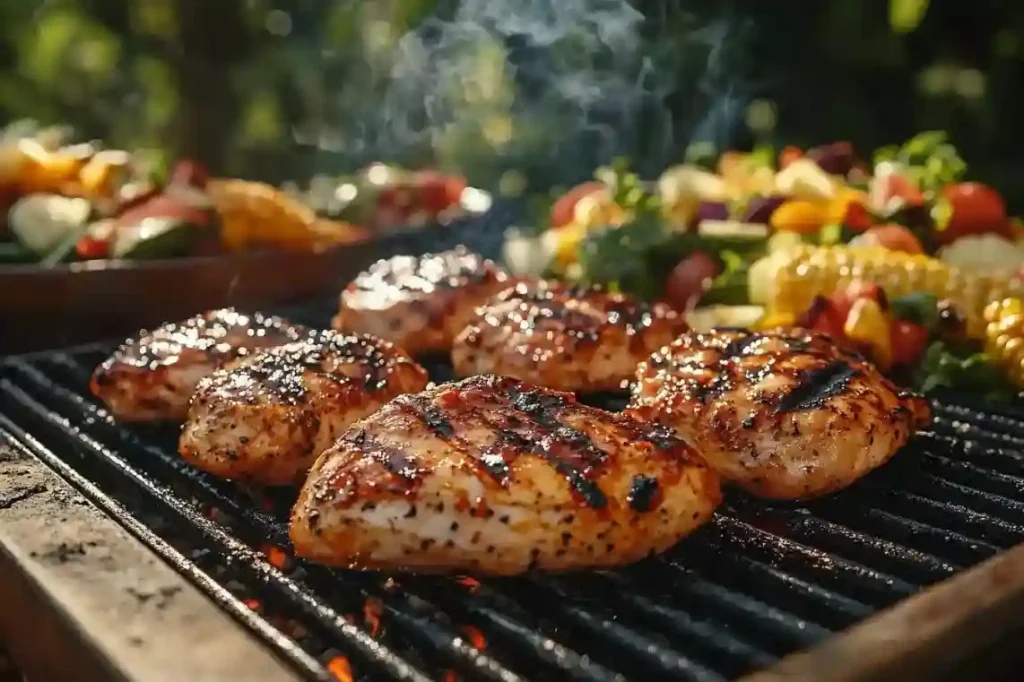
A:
[767,246,1024,339]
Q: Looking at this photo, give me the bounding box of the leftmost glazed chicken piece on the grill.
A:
[89,308,306,422]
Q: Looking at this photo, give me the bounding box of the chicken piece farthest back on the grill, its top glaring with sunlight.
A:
[332,247,510,354]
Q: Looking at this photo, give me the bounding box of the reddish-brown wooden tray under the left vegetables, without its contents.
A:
[0,242,382,353]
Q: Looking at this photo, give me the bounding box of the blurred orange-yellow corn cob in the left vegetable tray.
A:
[207,179,361,251]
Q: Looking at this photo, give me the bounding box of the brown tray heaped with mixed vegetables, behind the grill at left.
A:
[0,124,490,351]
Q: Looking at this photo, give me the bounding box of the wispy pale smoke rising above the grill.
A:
[317,0,736,183]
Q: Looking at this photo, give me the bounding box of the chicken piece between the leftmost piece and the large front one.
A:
[178,332,427,485]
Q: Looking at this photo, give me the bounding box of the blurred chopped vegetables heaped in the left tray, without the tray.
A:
[0,123,479,266]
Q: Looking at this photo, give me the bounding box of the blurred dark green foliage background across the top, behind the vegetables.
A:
[0,0,1024,210]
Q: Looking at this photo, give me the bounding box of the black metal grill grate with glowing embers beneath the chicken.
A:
[6,302,1024,682]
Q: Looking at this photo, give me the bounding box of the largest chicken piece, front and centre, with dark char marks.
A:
[291,376,721,574]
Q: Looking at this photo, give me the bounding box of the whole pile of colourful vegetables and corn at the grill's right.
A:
[505,132,1024,400]
